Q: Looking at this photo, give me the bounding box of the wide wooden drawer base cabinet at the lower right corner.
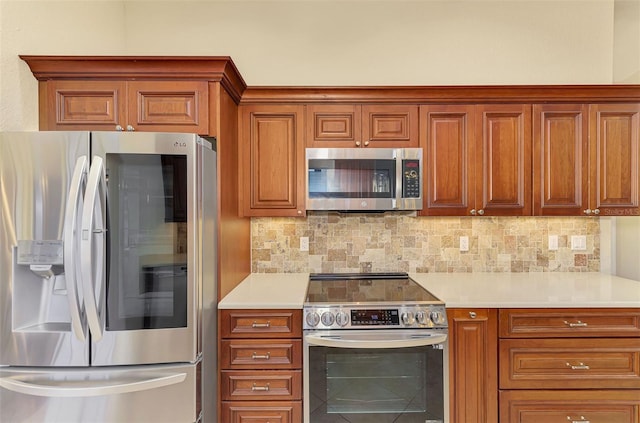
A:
[498,308,640,423]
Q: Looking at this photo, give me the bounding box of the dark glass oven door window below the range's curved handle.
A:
[309,346,444,423]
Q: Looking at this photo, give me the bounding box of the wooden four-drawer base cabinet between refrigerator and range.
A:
[219,310,302,423]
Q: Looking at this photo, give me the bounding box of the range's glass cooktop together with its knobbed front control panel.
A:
[303,273,447,330]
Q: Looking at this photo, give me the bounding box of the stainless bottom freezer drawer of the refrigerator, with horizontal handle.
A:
[0,364,200,423]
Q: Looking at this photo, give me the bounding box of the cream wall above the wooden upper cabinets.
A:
[0,0,640,130]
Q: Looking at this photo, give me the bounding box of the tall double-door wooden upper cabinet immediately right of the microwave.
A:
[420,104,531,216]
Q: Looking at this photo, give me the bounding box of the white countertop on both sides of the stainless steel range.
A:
[219,272,640,309]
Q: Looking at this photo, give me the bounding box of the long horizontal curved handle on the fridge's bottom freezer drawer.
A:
[0,373,187,397]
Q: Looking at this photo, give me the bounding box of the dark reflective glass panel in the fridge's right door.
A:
[106,154,188,331]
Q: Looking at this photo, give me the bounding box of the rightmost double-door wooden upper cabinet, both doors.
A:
[533,104,640,216]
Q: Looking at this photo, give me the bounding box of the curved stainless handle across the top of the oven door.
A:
[304,331,447,349]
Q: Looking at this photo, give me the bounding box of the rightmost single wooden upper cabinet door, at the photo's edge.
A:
[590,104,640,216]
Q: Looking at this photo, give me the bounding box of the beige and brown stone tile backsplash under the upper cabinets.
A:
[251,212,600,273]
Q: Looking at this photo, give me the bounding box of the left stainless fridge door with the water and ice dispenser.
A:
[0,132,89,366]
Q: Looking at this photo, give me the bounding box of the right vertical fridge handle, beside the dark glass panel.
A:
[80,156,107,342]
